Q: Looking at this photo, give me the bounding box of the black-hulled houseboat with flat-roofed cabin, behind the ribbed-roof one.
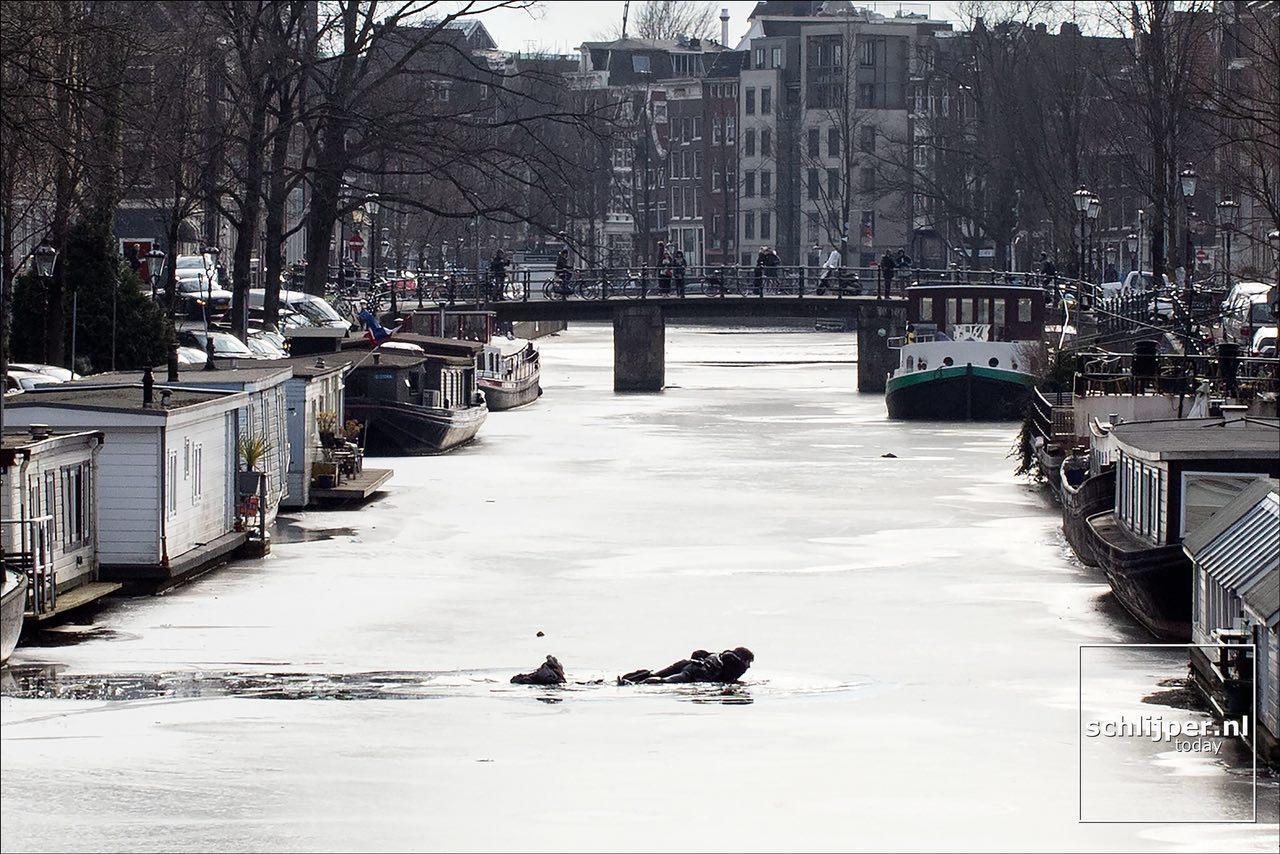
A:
[1085,417,1280,643]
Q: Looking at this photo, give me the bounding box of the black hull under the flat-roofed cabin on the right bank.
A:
[1085,511,1192,643]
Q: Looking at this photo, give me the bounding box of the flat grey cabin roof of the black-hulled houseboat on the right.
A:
[1111,417,1280,461]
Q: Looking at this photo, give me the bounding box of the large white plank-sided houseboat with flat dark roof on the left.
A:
[5,383,248,586]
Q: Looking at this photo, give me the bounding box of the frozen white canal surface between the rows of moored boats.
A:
[0,326,1277,851]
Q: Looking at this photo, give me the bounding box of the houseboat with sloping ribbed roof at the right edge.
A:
[1183,479,1280,767]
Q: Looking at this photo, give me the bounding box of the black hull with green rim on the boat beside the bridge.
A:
[884,365,1036,421]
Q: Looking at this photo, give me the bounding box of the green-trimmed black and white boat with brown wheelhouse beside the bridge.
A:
[884,283,1044,420]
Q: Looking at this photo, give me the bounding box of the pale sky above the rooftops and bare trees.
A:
[481,0,959,54]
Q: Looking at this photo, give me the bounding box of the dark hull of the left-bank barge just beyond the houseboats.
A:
[347,399,489,457]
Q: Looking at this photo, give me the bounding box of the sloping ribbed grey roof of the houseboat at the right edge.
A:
[1183,478,1280,616]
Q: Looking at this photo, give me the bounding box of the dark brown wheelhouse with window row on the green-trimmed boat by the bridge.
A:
[906,283,1044,342]
